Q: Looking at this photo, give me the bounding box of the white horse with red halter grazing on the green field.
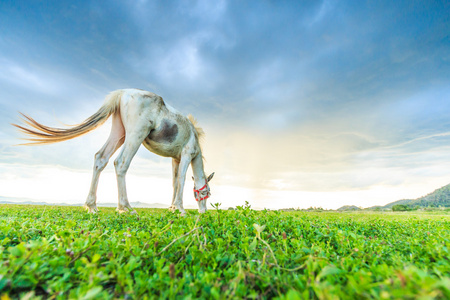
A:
[12,89,214,215]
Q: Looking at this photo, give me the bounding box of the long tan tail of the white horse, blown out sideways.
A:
[12,90,123,145]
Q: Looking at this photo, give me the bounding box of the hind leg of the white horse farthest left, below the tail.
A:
[85,112,125,213]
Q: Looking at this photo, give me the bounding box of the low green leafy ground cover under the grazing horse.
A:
[0,205,450,300]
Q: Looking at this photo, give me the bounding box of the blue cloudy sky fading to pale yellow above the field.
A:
[0,0,450,209]
